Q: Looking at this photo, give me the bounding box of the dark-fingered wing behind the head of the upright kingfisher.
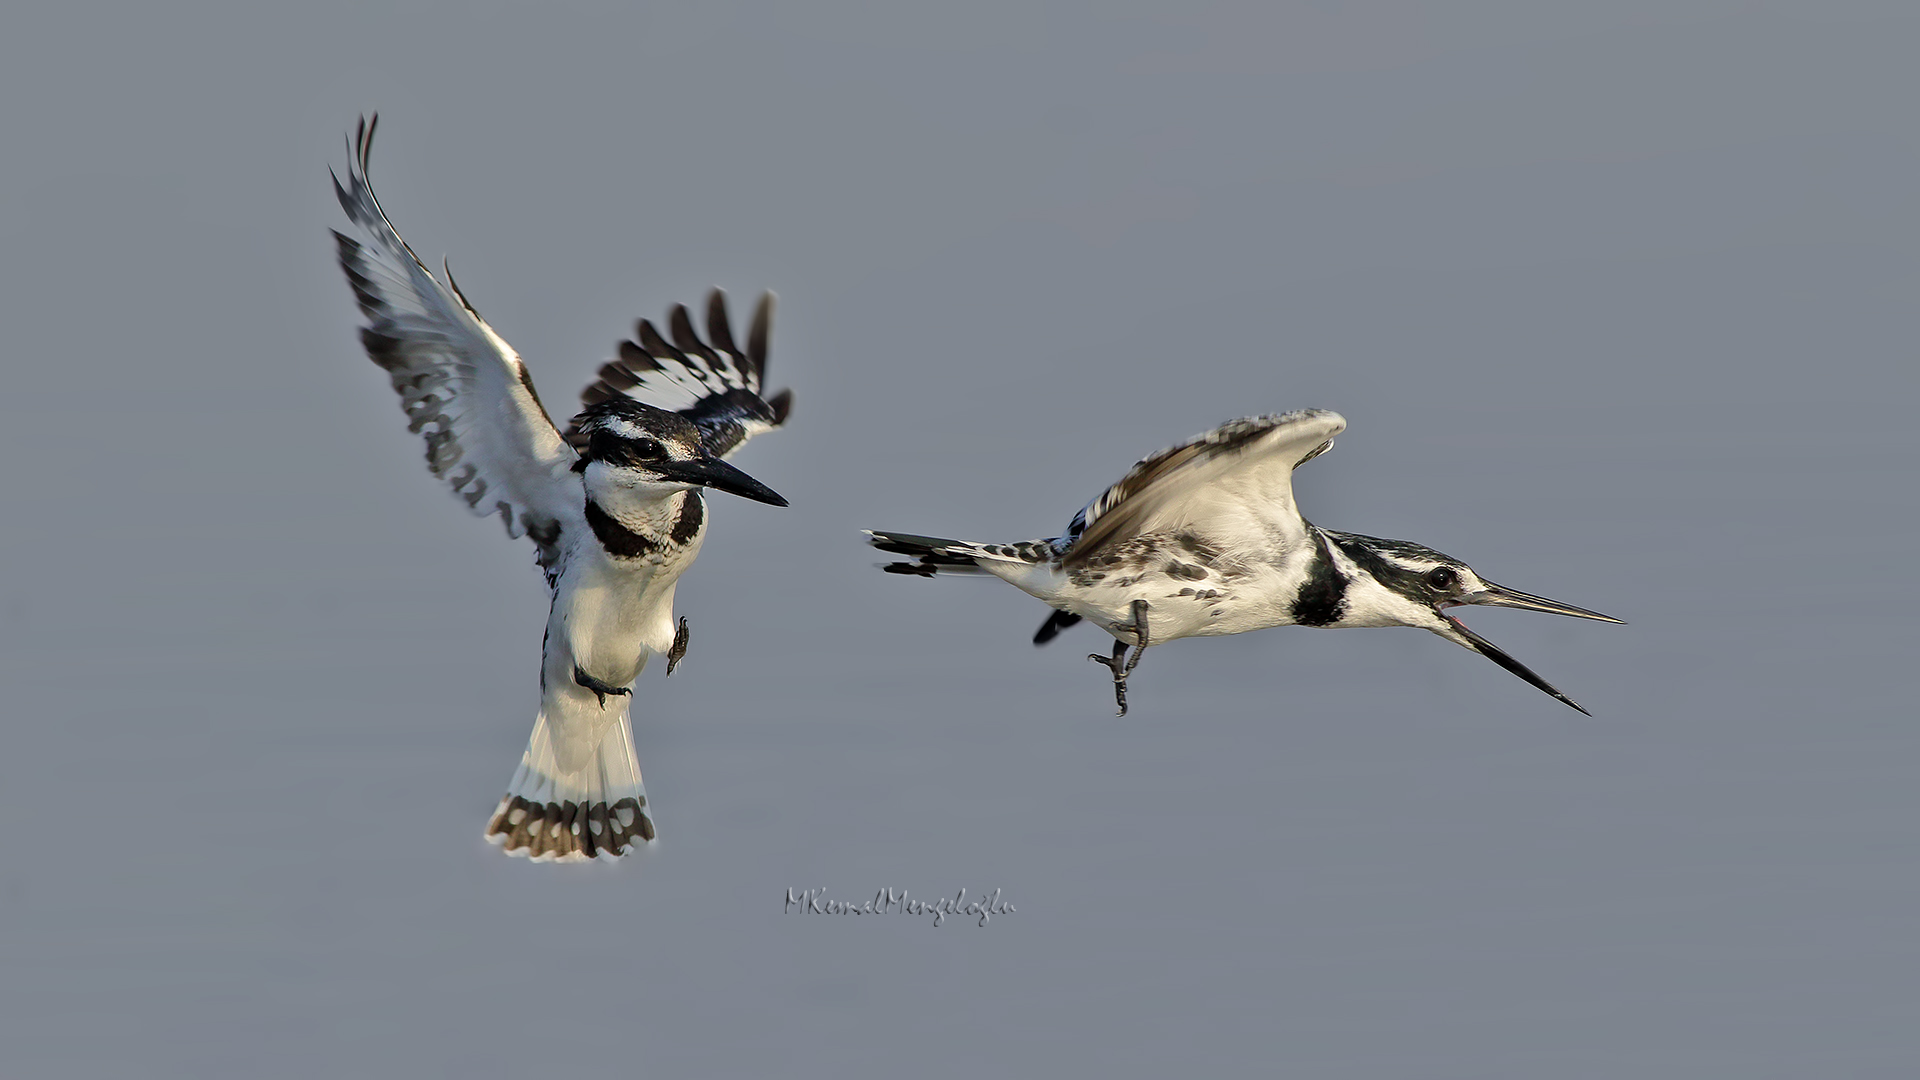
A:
[566,288,793,457]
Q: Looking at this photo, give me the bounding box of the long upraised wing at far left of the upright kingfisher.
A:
[334,115,582,575]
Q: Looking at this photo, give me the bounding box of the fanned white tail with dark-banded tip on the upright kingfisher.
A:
[486,711,653,863]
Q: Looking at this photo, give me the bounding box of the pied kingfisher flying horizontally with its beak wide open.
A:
[868,409,1619,717]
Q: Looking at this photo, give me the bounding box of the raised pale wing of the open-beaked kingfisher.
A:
[1062,409,1346,567]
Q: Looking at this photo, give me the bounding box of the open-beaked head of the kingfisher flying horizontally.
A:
[1329,534,1620,713]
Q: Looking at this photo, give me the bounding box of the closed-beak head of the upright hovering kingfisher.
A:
[574,398,787,505]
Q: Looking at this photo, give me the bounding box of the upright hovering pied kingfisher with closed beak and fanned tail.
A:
[334,117,793,861]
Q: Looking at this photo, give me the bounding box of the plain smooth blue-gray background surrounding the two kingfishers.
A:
[0,0,1920,1080]
